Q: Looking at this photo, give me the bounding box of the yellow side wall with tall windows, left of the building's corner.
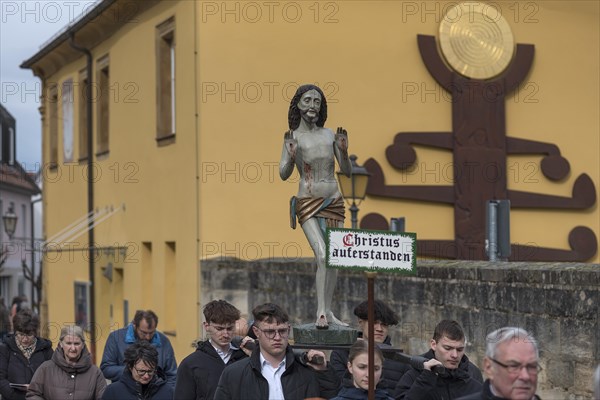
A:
[44,1,199,360]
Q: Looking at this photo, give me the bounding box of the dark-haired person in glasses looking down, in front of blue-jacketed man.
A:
[102,341,173,400]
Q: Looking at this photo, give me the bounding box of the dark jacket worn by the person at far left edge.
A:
[0,335,53,400]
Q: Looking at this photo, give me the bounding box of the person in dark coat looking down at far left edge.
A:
[0,309,52,400]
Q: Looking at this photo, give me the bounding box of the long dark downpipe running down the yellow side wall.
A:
[69,32,96,363]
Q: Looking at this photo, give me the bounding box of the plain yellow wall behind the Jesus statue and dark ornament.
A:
[198,1,600,262]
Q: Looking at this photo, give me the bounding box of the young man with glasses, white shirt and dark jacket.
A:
[214,303,338,400]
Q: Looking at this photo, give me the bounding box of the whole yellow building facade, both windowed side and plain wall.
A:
[24,0,600,361]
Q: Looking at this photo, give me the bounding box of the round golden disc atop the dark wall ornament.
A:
[439,2,515,79]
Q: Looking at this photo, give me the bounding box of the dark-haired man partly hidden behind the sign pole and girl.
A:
[331,300,410,395]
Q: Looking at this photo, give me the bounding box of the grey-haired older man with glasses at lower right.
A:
[461,327,542,400]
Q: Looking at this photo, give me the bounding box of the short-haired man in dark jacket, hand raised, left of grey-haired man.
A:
[394,320,483,400]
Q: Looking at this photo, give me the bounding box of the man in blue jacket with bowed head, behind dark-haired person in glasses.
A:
[100,310,177,389]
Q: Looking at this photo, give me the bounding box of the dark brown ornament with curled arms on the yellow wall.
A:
[360,2,598,261]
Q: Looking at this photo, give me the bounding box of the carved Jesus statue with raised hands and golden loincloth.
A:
[279,85,351,329]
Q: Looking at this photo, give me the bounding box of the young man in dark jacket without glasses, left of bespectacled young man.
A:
[175,300,253,400]
